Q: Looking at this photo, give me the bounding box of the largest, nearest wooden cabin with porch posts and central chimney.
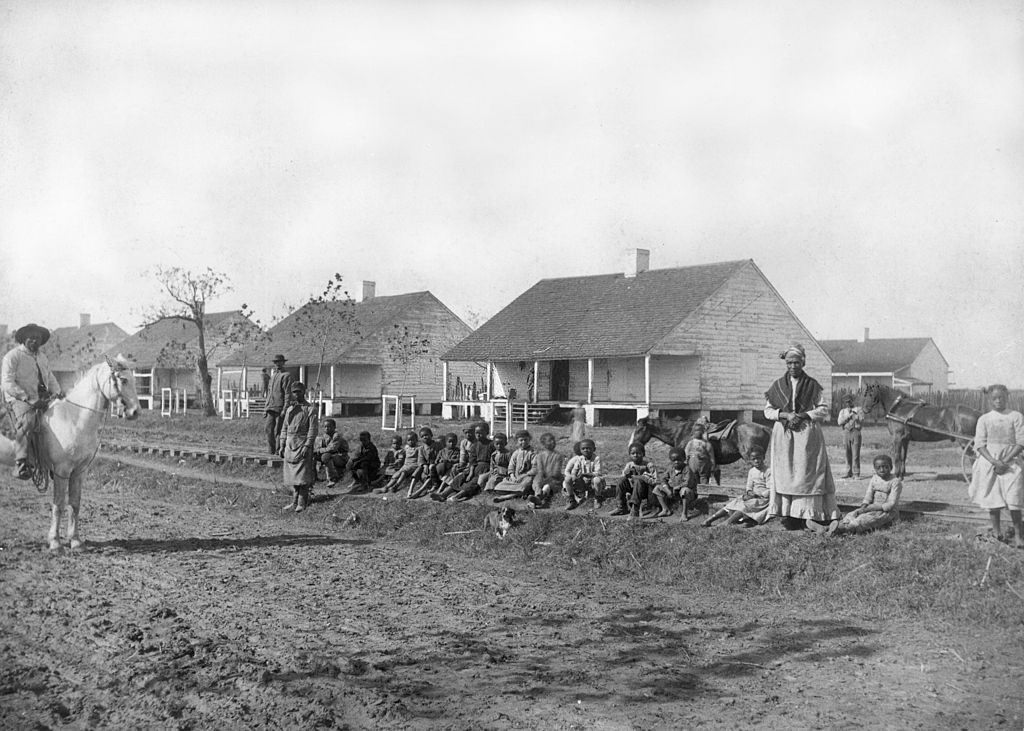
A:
[443,250,831,424]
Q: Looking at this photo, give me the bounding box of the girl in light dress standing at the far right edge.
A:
[969,383,1024,549]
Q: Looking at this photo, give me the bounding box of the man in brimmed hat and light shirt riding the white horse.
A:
[0,323,63,480]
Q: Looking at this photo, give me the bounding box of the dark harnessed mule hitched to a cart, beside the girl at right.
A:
[863,384,981,478]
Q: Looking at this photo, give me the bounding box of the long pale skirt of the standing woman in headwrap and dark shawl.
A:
[768,422,841,522]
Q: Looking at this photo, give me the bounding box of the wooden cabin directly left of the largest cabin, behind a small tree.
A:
[217,282,484,416]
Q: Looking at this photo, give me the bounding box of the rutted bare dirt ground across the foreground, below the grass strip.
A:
[0,446,1024,729]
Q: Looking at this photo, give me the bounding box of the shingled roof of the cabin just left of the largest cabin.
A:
[217,291,446,367]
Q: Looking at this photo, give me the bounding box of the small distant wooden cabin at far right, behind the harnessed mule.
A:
[819,328,949,395]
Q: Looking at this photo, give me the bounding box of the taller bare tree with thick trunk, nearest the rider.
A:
[144,266,236,417]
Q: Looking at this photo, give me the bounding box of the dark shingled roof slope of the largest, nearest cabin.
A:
[442,259,753,360]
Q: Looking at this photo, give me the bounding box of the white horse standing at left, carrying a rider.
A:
[0,357,138,551]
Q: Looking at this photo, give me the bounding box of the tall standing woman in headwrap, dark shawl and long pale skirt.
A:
[765,344,840,531]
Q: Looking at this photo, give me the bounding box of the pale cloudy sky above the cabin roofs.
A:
[0,0,1024,387]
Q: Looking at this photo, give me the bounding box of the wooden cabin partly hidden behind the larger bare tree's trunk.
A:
[106,310,260,410]
